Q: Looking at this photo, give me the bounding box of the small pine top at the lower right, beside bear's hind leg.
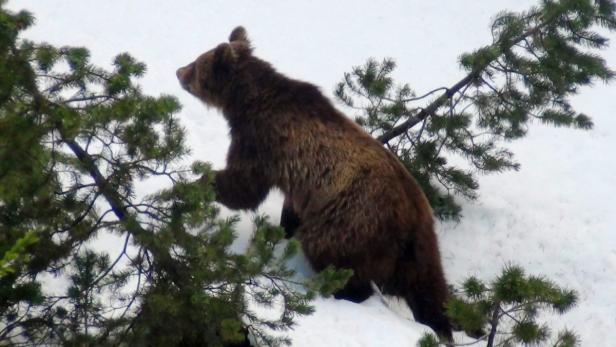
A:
[418,266,579,347]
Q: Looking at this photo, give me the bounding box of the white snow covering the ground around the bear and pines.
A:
[9,0,616,346]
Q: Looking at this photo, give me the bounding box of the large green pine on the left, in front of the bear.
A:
[0,0,349,346]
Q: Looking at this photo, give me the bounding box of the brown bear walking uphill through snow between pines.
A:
[177,27,451,339]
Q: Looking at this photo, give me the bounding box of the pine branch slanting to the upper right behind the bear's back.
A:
[335,0,616,218]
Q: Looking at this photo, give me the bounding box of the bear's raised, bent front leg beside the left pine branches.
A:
[208,169,271,210]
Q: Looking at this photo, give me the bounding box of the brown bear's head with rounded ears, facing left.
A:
[176,26,252,108]
